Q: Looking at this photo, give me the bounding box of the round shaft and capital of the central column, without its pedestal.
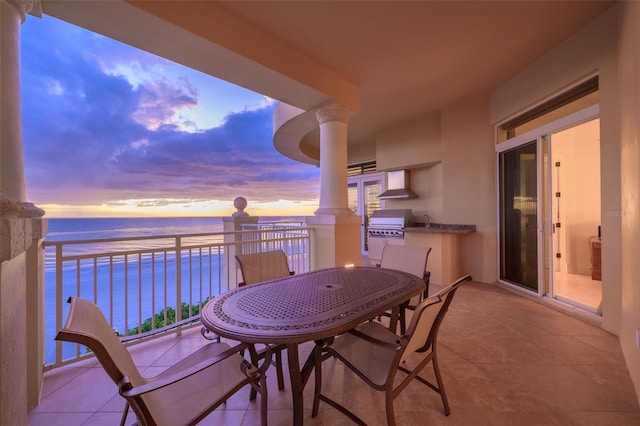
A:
[315,103,353,215]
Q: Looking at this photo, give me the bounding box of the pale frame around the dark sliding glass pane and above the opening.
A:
[495,104,602,297]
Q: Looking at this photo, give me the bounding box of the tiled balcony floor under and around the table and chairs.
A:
[29,283,640,426]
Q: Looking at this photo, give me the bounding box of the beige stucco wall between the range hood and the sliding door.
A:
[376,97,496,282]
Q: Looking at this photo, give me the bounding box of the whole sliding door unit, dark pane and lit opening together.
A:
[496,105,602,302]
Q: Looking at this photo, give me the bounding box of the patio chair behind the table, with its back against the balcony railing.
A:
[236,250,295,394]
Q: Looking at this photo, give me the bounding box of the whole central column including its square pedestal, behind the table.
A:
[307,103,362,270]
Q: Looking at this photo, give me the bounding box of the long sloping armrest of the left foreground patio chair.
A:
[118,343,271,397]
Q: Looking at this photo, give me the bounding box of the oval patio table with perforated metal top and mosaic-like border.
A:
[200,267,424,425]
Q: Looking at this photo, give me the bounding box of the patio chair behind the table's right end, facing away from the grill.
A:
[376,244,431,334]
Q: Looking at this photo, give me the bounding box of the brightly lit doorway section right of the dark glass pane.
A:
[545,118,602,315]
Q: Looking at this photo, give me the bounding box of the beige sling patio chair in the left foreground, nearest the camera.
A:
[56,297,271,425]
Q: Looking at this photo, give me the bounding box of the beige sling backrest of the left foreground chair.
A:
[56,297,144,386]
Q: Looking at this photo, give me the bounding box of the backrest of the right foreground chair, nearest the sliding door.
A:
[400,275,472,362]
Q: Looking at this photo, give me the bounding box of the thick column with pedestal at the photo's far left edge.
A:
[0,0,47,424]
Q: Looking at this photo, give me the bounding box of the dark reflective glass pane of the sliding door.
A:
[499,140,538,292]
